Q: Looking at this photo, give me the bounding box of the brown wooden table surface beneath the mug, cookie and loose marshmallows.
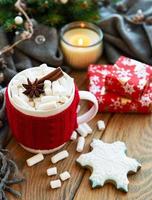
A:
[7,69,152,200]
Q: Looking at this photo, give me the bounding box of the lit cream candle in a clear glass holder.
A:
[60,21,103,69]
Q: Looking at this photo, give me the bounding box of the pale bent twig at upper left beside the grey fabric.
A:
[0,0,34,56]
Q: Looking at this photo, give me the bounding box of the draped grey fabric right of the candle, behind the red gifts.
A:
[99,0,152,65]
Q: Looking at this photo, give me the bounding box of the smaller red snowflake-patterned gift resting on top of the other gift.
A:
[105,56,152,99]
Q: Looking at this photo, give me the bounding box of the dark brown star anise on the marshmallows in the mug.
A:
[23,78,44,98]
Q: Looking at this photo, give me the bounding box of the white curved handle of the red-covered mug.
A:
[77,91,98,124]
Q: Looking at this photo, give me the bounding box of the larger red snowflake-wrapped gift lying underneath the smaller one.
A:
[88,65,152,113]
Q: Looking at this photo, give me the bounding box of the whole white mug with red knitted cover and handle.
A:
[6,67,98,154]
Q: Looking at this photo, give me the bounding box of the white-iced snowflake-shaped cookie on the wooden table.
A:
[77,139,141,192]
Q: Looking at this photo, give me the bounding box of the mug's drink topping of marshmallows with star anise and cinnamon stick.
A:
[9,64,74,116]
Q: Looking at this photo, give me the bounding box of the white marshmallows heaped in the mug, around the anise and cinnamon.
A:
[10,64,73,111]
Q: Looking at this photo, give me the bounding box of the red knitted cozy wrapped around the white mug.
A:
[6,88,79,150]
